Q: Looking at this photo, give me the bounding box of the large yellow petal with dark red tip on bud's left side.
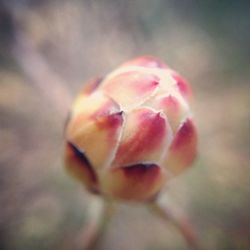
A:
[66,92,123,169]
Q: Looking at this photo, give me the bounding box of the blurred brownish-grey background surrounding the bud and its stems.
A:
[0,0,250,250]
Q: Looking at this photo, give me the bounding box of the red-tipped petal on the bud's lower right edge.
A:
[162,119,197,175]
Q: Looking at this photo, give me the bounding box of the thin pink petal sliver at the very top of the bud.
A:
[121,56,168,69]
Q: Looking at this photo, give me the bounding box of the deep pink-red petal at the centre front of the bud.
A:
[113,108,171,166]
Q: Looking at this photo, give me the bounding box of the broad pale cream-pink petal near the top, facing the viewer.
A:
[102,71,159,109]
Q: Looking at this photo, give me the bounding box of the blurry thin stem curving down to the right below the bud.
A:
[149,201,201,250]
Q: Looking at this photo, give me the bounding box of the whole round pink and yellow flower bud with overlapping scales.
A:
[65,56,197,201]
